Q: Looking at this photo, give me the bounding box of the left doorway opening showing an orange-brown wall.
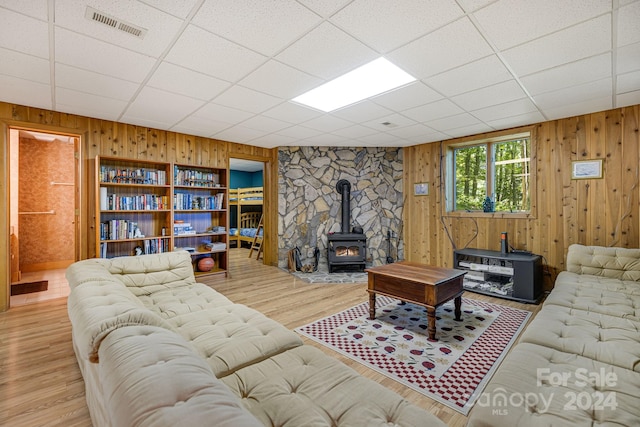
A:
[9,128,80,306]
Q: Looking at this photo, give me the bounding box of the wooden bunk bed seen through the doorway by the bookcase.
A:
[229,187,264,248]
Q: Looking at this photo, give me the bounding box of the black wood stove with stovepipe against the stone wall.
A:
[327,179,367,273]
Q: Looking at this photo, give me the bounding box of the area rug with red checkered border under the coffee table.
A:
[296,296,531,415]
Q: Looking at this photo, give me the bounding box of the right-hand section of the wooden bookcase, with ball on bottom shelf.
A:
[173,164,229,276]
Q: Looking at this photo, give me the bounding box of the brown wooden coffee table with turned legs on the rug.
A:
[365,261,466,340]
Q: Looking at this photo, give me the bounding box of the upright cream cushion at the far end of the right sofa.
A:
[567,244,640,282]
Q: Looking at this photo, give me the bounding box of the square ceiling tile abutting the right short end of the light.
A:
[388,18,493,79]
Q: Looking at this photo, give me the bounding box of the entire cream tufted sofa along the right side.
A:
[467,244,640,427]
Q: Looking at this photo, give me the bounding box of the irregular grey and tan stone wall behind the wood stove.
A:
[278,147,403,271]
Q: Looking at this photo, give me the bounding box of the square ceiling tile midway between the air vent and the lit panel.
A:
[165,25,266,82]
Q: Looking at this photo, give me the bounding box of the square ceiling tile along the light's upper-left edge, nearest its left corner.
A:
[238,60,323,99]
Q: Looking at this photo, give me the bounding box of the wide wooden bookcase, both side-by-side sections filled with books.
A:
[96,156,229,276]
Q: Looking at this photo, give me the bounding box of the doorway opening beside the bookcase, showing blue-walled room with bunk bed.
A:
[229,158,268,259]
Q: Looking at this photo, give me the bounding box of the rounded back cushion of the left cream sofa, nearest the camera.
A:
[99,326,262,427]
